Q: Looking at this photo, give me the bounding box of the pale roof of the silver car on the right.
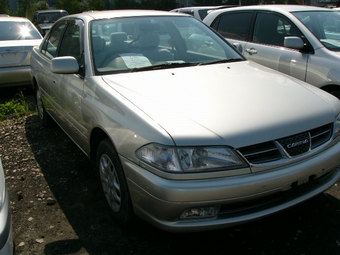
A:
[208,4,332,15]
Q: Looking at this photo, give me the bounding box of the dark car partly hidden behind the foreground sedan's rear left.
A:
[32,10,68,36]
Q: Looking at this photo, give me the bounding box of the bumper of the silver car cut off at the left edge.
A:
[0,66,31,87]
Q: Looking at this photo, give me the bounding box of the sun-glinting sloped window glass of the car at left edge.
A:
[0,21,41,41]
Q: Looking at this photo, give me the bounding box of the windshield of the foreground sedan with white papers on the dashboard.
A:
[90,16,244,75]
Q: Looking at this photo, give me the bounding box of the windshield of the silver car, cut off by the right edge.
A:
[293,11,340,51]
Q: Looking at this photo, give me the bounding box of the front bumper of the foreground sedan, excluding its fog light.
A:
[121,139,340,232]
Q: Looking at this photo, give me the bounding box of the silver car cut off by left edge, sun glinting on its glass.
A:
[0,16,42,87]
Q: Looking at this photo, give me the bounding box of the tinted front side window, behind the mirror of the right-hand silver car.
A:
[253,13,301,46]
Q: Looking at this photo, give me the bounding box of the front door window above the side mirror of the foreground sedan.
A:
[58,21,81,64]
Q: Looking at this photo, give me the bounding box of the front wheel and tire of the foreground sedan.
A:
[96,138,135,226]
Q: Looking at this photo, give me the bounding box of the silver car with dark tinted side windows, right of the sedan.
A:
[204,5,340,99]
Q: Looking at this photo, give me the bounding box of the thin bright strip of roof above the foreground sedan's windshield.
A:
[62,10,188,19]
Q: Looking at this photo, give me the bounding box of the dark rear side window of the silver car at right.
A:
[213,12,253,41]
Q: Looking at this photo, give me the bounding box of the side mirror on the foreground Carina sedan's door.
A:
[51,56,79,74]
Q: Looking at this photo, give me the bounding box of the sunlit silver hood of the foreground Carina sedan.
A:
[103,61,339,148]
